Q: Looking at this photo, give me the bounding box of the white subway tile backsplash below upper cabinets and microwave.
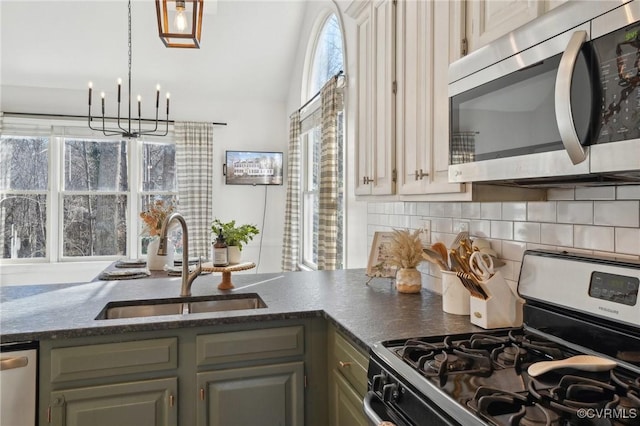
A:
[367,185,640,286]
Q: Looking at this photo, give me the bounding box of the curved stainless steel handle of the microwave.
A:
[555,31,587,164]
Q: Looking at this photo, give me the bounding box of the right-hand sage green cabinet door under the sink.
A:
[197,362,304,426]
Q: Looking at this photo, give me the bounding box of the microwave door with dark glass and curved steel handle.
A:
[449,24,599,182]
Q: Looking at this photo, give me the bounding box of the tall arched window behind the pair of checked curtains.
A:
[300,13,344,269]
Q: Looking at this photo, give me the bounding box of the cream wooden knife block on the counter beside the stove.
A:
[469,271,522,329]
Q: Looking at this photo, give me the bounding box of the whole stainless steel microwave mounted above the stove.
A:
[449,0,640,186]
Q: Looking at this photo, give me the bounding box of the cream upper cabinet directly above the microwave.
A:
[466,0,568,52]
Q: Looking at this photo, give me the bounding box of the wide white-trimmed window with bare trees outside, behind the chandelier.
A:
[0,119,177,263]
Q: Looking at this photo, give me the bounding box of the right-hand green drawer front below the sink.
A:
[196,326,304,366]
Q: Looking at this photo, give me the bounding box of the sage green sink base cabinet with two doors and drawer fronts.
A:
[38,318,328,426]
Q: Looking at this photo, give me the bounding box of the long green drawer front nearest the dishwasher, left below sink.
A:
[51,337,178,383]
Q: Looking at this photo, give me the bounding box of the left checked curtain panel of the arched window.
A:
[282,111,301,271]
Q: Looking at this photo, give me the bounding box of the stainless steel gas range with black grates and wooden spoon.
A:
[365,250,640,426]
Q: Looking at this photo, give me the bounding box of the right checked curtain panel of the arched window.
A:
[318,78,339,270]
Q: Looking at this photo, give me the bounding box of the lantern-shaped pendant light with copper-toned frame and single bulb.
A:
[156,0,204,49]
